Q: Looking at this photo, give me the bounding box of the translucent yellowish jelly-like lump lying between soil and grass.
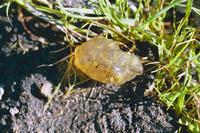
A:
[74,37,143,85]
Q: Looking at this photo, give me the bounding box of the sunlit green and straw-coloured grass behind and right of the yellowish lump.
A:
[1,0,200,132]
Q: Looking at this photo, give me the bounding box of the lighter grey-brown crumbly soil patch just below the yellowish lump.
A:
[7,74,175,133]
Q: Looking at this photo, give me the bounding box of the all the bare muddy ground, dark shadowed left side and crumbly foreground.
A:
[0,2,181,133]
